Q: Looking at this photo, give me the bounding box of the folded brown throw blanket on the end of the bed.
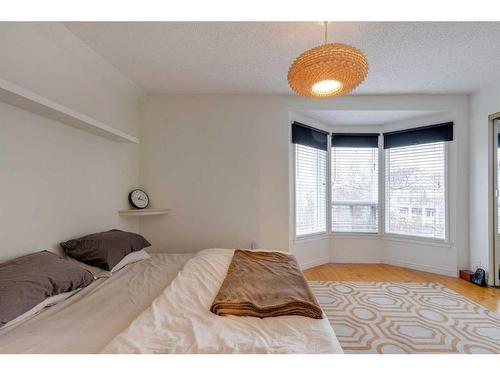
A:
[210,250,323,319]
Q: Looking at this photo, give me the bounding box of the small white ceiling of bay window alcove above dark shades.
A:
[296,111,437,127]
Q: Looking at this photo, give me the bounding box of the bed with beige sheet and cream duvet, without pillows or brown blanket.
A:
[0,249,342,353]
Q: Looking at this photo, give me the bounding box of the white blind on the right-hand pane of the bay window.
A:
[385,142,446,239]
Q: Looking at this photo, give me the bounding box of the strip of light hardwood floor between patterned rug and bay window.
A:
[304,263,500,314]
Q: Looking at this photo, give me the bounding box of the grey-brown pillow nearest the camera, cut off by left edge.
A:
[0,251,94,327]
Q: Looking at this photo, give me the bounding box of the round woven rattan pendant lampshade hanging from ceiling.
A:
[288,35,368,98]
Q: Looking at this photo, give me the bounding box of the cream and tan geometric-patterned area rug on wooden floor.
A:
[309,281,500,354]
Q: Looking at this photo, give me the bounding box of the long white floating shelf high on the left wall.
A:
[0,78,139,143]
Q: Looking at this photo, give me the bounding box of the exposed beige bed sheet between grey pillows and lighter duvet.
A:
[0,254,194,353]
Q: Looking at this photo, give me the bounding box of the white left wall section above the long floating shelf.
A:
[0,22,142,136]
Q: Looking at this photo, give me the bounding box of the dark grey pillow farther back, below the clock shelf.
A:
[61,229,151,271]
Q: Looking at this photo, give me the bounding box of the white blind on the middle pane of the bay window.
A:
[331,147,378,233]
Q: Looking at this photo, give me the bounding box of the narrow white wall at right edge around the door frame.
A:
[469,82,500,283]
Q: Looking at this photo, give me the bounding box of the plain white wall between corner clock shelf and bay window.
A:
[141,95,288,252]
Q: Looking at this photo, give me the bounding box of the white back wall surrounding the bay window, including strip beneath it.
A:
[141,95,468,272]
